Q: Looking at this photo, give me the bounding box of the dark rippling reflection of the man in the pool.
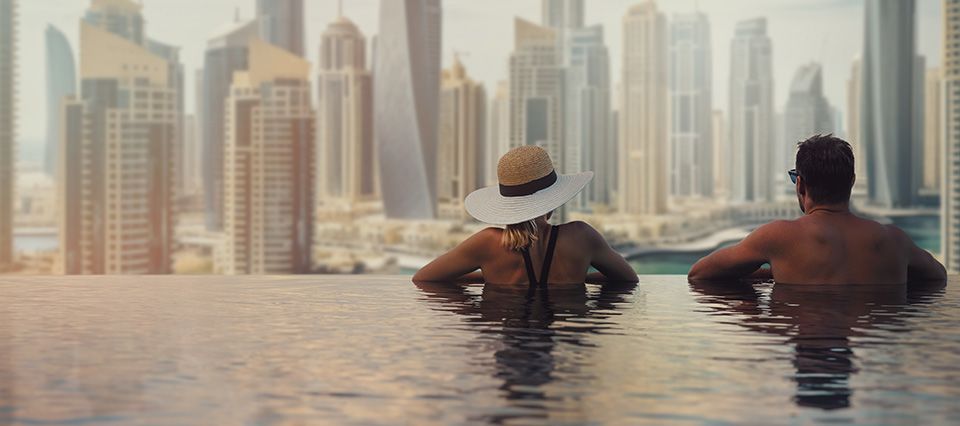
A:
[691,282,945,410]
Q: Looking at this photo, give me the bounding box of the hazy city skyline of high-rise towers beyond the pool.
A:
[0,0,947,274]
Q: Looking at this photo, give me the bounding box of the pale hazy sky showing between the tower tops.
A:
[13,0,942,156]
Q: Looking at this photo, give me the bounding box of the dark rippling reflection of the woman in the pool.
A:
[417,283,636,423]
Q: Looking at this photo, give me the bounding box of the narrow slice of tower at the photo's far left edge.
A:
[0,0,17,268]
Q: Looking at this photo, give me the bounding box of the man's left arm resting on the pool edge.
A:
[687,222,784,280]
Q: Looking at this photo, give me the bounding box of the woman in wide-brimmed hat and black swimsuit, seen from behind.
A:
[413,146,638,288]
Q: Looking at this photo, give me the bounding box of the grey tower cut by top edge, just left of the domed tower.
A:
[257,0,304,57]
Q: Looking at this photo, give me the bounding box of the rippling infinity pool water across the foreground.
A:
[0,276,960,424]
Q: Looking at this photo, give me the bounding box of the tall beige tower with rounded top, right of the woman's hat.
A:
[618,0,669,215]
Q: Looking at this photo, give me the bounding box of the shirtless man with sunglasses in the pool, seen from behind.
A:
[688,135,946,284]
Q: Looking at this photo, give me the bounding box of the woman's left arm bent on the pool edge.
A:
[413,228,495,282]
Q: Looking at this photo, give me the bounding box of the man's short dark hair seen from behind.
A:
[797,134,854,203]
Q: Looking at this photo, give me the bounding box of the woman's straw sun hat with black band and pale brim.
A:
[464,145,593,225]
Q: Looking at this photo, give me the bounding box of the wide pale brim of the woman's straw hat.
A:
[463,172,593,225]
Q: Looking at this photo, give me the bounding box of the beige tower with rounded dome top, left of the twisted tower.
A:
[316,16,379,209]
